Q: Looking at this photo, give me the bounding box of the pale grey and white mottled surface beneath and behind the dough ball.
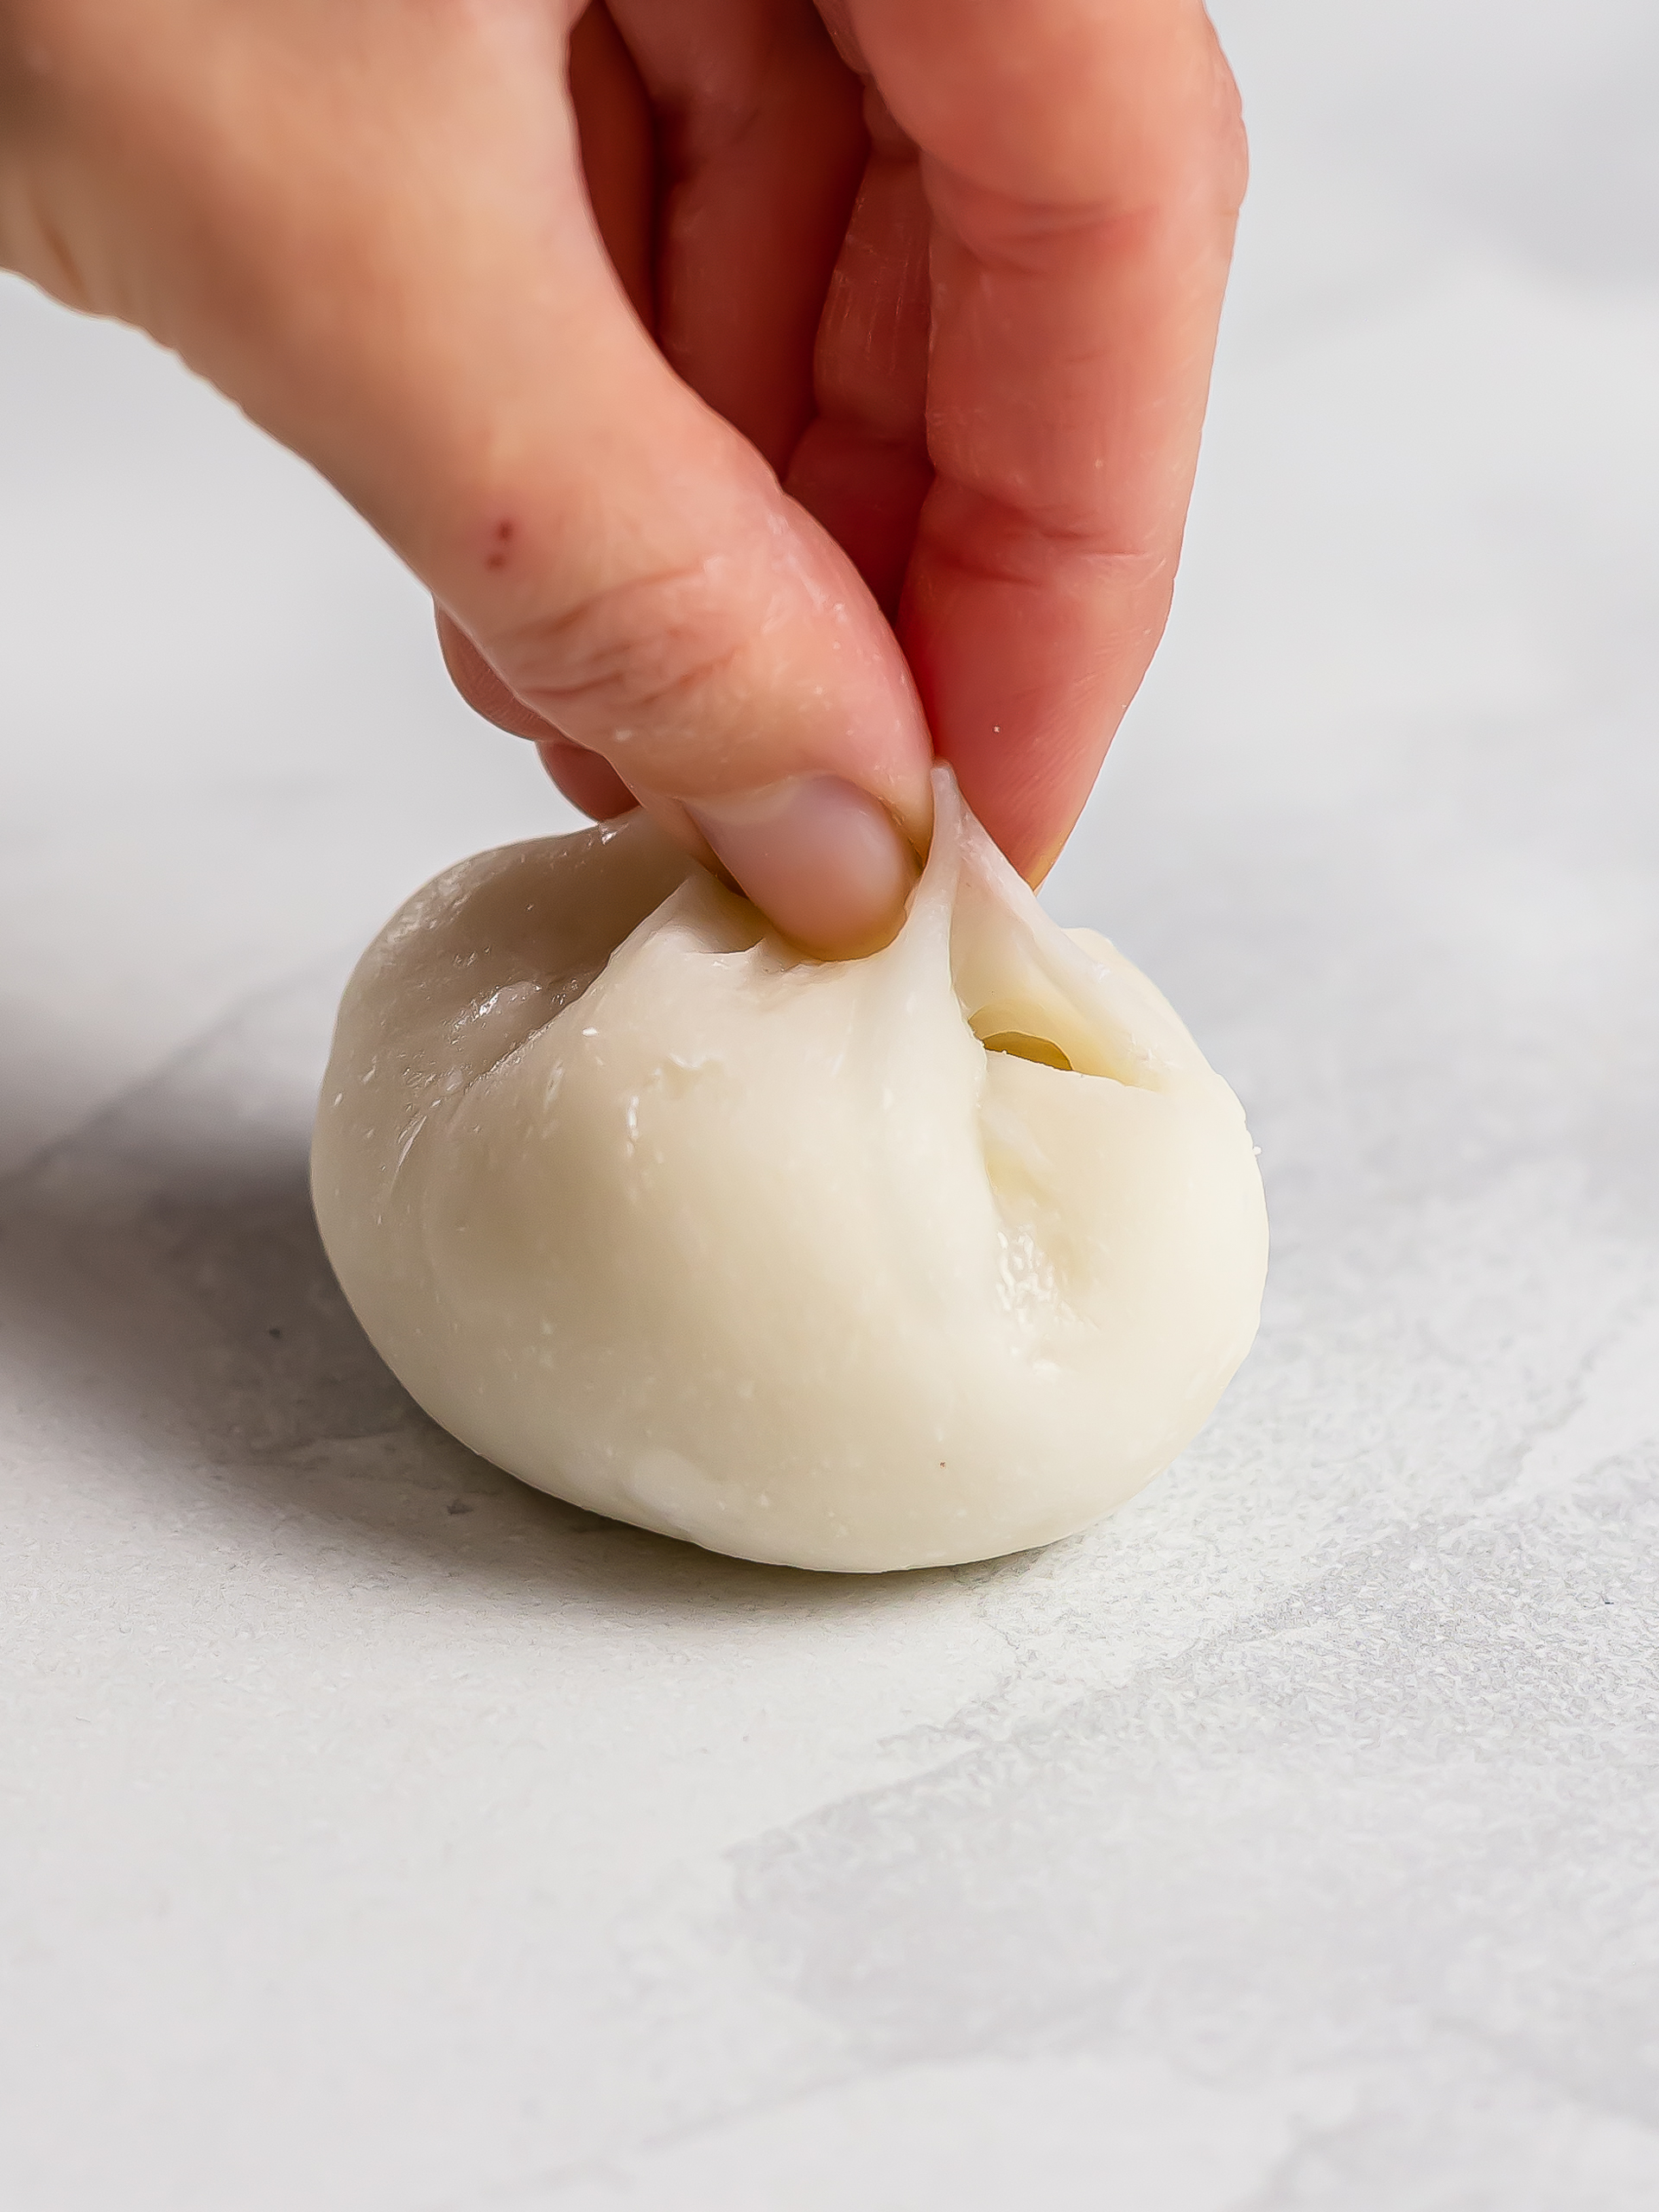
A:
[0,0,1659,2212]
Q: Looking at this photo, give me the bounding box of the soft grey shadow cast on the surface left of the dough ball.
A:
[0,978,949,1615]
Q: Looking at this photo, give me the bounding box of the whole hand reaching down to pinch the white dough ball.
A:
[0,0,1245,953]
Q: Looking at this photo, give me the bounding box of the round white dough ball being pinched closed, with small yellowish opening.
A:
[312,770,1268,1573]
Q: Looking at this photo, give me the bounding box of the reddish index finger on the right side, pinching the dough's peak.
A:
[849,0,1245,880]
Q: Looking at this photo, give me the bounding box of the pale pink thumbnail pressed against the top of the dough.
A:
[686,777,918,957]
